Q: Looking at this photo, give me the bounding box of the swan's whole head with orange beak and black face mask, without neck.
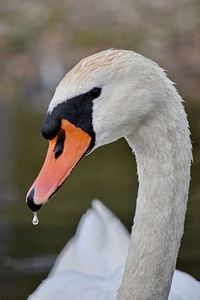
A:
[26,49,175,211]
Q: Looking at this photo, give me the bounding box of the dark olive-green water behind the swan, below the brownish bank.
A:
[0,99,200,300]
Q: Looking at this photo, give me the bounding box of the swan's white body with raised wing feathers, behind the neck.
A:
[28,200,200,300]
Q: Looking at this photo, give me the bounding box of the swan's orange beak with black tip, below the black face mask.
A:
[26,119,92,211]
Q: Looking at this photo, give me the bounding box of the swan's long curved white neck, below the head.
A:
[117,89,192,300]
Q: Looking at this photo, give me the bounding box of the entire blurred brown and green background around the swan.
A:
[0,0,200,300]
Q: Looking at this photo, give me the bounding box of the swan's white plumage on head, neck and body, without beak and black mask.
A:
[29,49,200,300]
